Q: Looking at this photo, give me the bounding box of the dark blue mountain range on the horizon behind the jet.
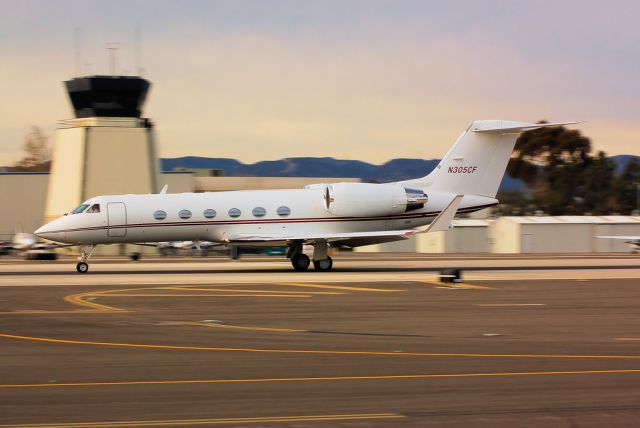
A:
[161,155,640,190]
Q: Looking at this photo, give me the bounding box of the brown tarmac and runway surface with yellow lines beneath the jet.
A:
[0,256,640,428]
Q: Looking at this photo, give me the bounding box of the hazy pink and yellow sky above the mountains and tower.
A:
[0,0,640,164]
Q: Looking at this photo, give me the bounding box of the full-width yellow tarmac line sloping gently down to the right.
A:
[0,333,640,360]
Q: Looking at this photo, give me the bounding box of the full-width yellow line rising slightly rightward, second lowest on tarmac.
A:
[0,369,640,392]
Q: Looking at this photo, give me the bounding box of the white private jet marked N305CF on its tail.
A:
[35,120,576,273]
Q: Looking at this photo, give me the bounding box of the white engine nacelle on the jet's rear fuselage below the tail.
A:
[307,183,427,217]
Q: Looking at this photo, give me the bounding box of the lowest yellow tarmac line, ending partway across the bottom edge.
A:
[0,413,406,428]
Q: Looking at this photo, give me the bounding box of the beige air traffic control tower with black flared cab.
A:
[45,76,159,222]
